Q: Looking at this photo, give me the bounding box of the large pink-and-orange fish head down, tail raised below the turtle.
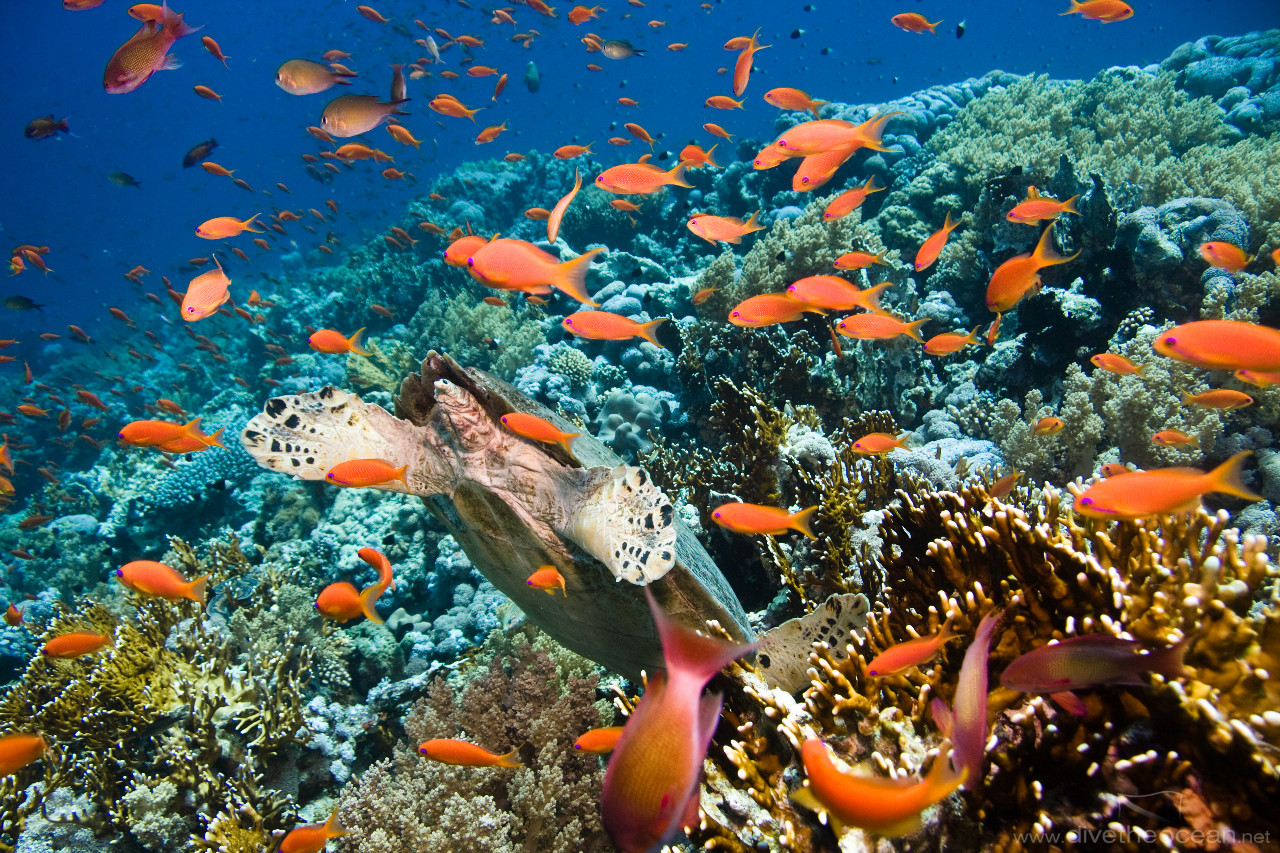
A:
[600,587,754,853]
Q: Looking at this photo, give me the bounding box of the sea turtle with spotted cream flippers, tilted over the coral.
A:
[241,351,754,679]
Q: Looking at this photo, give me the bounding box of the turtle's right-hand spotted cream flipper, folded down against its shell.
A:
[557,465,676,585]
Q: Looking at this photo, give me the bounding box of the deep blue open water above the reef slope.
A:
[0,0,1280,345]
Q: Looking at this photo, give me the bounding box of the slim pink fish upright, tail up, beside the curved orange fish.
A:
[929,608,1005,790]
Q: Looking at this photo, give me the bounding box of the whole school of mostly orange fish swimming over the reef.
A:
[0,0,1280,853]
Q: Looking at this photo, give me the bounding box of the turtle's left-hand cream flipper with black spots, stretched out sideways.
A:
[241,386,445,494]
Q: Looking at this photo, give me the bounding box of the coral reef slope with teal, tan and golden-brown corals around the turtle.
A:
[0,31,1280,853]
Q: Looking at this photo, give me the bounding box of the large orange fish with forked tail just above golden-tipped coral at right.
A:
[1075,451,1262,520]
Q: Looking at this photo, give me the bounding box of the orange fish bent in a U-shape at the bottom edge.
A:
[791,739,966,838]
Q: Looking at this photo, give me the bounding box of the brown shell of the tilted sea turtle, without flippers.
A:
[396,351,754,679]
